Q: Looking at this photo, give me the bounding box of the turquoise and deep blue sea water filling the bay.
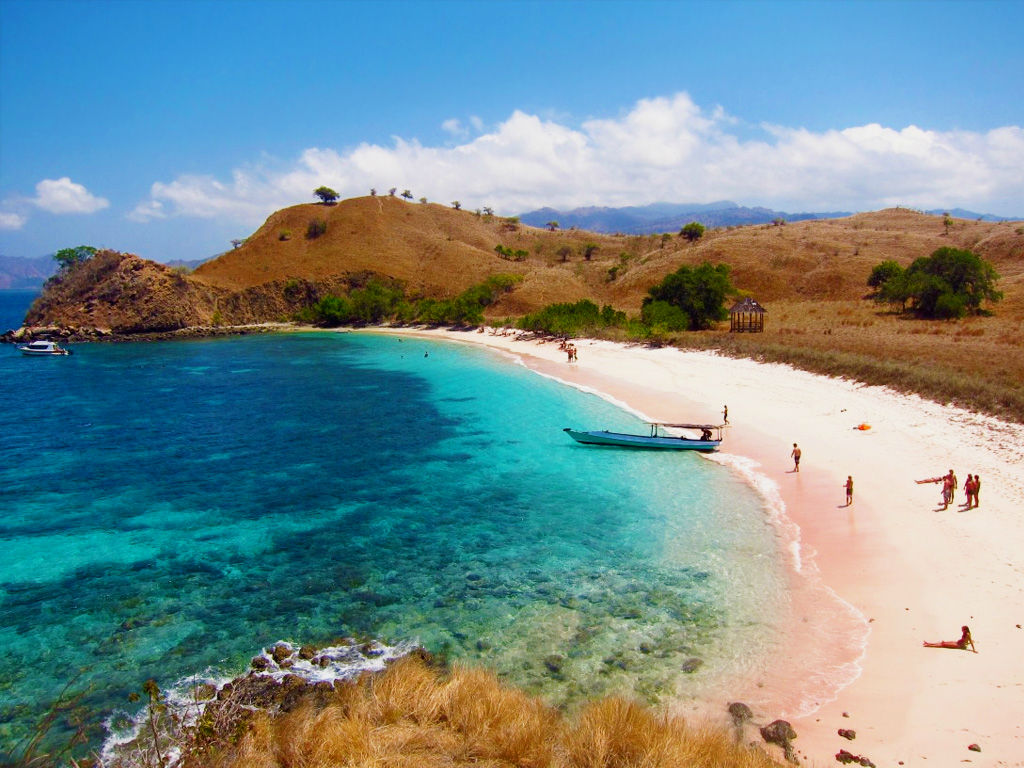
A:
[0,292,787,762]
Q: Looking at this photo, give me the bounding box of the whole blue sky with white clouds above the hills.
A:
[0,0,1024,261]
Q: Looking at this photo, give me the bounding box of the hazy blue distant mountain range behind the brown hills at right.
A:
[519,200,1008,234]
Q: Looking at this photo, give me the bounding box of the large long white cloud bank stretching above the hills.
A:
[128,93,1024,225]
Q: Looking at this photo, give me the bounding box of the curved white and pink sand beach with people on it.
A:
[370,331,1024,766]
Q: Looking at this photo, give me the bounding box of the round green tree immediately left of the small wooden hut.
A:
[641,261,736,331]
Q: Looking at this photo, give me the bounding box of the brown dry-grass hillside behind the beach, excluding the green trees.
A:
[201,197,1024,422]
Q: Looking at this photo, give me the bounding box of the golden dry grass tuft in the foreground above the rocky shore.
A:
[187,657,777,768]
